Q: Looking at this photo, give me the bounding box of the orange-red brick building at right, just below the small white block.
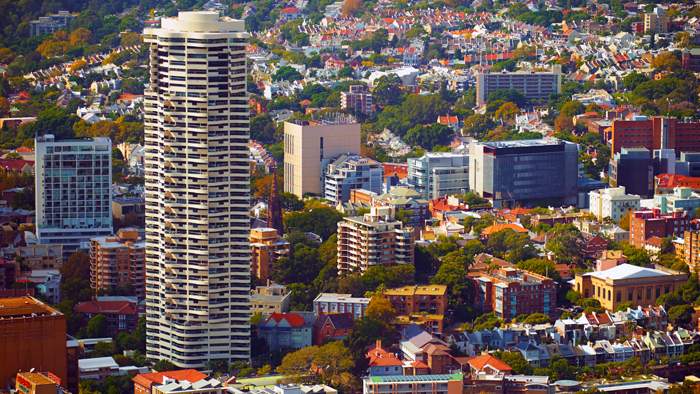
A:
[630,209,690,248]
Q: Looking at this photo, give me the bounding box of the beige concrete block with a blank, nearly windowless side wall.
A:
[284,115,360,198]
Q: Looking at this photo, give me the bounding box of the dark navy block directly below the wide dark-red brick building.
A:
[609,148,654,197]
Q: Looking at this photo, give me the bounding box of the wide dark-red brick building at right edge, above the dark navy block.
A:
[608,116,700,153]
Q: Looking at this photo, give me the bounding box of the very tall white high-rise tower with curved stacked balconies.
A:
[144,12,250,368]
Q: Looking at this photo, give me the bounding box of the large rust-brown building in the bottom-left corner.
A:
[0,296,67,386]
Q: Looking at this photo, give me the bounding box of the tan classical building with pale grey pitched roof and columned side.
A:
[574,263,688,311]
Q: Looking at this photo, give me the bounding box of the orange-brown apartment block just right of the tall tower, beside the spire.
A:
[249,227,290,282]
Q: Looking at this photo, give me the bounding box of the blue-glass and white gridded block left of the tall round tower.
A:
[35,134,112,256]
